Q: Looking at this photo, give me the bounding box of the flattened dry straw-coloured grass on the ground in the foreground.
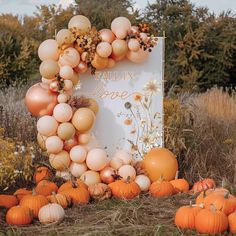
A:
[0,194,195,236]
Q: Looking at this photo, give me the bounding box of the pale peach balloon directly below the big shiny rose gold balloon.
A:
[37,116,58,137]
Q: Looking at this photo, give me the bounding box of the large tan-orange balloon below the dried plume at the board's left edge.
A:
[72,107,95,133]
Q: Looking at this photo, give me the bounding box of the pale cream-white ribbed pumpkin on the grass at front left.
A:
[39,203,65,224]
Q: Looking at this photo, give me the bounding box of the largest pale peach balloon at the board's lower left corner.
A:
[86,148,108,171]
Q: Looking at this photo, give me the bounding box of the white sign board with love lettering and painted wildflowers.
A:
[77,38,164,158]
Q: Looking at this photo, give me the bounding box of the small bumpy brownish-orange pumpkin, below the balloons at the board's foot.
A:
[88,183,111,201]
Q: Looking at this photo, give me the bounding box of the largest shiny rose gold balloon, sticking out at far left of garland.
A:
[25,83,57,116]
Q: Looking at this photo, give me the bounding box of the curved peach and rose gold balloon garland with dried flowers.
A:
[25,15,157,180]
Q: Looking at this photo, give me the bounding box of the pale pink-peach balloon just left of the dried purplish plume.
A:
[53,103,73,122]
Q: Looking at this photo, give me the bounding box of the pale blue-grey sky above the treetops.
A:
[0,0,236,15]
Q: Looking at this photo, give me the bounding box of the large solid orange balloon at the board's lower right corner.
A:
[142,148,178,182]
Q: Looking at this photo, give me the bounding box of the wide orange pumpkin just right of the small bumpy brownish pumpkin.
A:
[108,178,141,199]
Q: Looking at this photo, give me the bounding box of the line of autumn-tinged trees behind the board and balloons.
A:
[0,0,236,93]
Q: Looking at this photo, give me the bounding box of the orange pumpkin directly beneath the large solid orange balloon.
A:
[149,179,175,197]
